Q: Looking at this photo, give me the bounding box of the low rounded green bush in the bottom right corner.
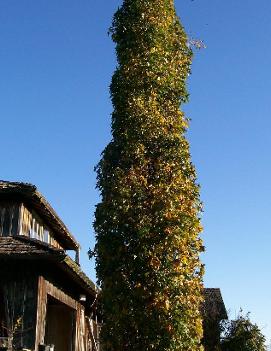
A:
[221,313,267,351]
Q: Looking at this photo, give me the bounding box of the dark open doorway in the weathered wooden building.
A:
[45,296,75,351]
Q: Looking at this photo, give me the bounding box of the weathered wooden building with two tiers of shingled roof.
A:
[0,181,99,351]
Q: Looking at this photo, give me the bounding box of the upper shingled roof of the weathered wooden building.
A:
[0,180,80,250]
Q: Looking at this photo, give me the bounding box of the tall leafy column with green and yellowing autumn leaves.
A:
[94,0,203,351]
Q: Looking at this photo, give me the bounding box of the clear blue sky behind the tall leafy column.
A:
[0,0,271,346]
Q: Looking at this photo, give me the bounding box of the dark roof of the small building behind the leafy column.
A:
[203,288,228,320]
